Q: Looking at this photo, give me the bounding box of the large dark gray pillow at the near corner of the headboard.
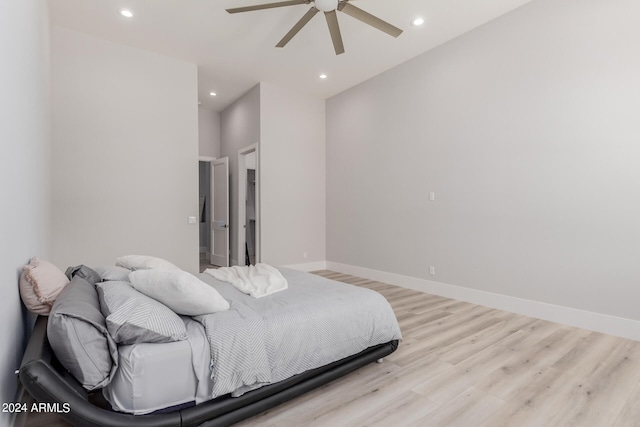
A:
[47,276,118,390]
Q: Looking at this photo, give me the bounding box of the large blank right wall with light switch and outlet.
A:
[327,0,640,336]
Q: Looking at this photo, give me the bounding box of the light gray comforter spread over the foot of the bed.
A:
[194,268,401,397]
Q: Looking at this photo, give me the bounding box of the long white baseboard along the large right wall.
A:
[325,261,640,341]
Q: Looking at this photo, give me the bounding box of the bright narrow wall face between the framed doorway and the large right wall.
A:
[259,83,326,265]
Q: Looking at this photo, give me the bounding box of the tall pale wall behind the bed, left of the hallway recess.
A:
[52,28,198,272]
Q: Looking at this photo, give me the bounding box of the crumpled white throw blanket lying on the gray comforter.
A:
[204,264,288,298]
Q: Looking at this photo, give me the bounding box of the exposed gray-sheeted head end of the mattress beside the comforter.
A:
[102,316,211,415]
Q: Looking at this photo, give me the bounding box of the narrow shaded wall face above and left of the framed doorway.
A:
[220,85,260,264]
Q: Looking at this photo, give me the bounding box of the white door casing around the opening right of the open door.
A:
[236,143,262,265]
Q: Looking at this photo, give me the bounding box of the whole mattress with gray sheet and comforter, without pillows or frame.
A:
[103,268,401,415]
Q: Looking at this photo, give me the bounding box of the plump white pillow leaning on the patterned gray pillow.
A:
[129,269,229,316]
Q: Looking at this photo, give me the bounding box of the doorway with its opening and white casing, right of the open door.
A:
[236,144,260,265]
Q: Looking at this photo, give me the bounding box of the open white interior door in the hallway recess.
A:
[210,157,229,267]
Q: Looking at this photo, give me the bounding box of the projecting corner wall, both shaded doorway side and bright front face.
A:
[220,82,326,265]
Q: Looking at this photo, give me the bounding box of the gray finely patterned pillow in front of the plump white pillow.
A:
[96,281,187,344]
